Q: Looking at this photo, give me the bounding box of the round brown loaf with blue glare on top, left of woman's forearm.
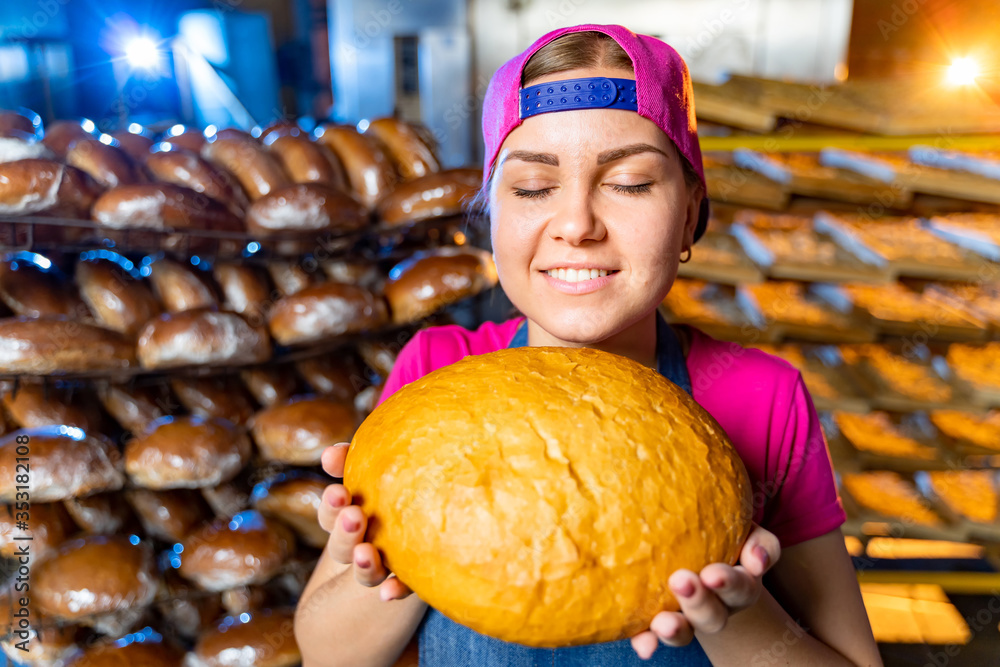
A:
[178,510,295,591]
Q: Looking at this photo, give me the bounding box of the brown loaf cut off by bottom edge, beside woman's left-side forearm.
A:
[186,610,302,667]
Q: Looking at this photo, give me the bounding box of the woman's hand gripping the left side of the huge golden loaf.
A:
[319,442,412,600]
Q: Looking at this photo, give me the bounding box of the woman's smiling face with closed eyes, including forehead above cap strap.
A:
[490,68,701,344]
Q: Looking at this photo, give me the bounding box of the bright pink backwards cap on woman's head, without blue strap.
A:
[483,24,708,241]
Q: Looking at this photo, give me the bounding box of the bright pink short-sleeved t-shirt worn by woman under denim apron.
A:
[379,317,847,547]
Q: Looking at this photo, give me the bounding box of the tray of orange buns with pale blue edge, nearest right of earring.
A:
[732,209,891,283]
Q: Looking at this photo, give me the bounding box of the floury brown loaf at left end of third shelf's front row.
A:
[0,426,125,503]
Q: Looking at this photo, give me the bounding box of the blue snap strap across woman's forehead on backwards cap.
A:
[518,76,639,119]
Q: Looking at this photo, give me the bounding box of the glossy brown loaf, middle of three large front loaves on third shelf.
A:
[125,417,250,489]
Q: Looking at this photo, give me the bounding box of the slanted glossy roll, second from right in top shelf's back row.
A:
[316,126,396,209]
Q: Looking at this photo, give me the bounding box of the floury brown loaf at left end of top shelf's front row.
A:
[0,158,100,218]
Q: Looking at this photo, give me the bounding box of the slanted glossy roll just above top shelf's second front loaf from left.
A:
[146,143,248,215]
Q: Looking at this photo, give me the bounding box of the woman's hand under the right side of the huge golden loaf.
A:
[632,524,781,660]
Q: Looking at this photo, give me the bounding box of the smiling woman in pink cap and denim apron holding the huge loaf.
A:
[296,25,881,667]
